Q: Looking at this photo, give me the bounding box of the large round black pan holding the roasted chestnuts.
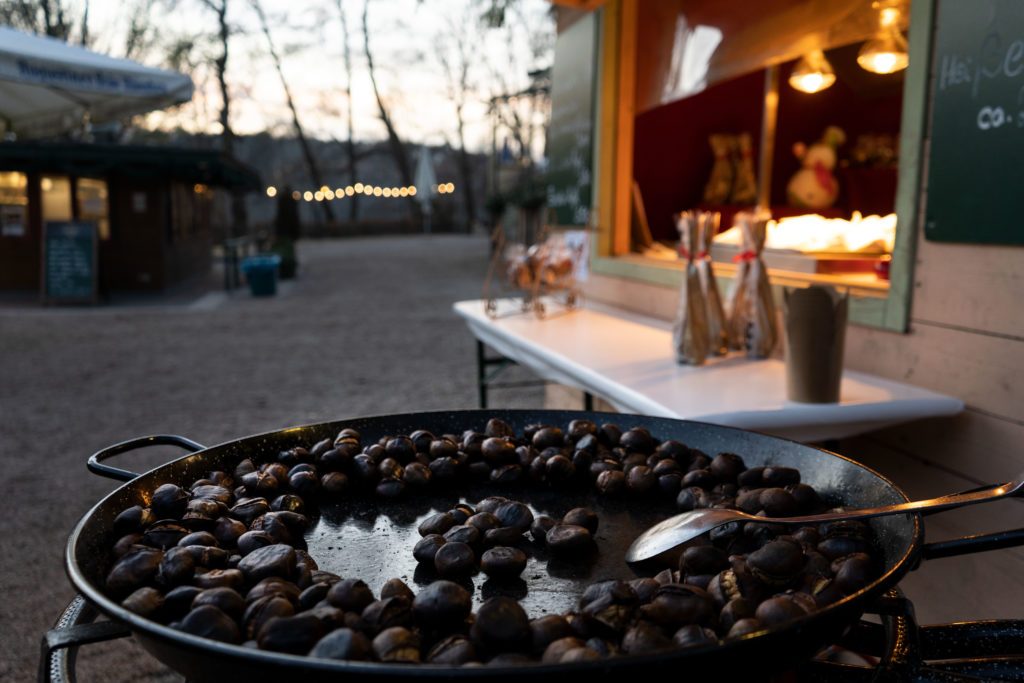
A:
[66,411,923,682]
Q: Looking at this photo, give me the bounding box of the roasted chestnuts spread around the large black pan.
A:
[105,420,877,666]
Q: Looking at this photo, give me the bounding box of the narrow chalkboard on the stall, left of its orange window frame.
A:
[547,12,598,225]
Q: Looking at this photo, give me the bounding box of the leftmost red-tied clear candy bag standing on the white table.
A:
[672,211,709,366]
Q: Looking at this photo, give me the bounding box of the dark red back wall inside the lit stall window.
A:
[633,45,903,240]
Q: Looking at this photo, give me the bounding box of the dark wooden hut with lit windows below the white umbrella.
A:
[0,142,260,294]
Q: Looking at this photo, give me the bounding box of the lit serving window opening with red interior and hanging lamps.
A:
[615,0,909,297]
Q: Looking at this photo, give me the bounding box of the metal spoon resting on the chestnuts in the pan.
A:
[626,472,1024,562]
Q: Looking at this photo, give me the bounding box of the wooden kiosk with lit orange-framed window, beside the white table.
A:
[548,0,1024,617]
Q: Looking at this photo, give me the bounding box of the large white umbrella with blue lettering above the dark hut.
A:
[0,27,193,137]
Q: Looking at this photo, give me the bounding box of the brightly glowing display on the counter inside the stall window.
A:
[715,211,896,254]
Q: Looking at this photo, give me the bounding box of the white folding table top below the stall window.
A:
[454,300,964,441]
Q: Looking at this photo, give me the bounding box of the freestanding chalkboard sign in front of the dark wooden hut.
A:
[43,221,97,302]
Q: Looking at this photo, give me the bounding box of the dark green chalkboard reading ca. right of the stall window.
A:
[925,0,1024,245]
